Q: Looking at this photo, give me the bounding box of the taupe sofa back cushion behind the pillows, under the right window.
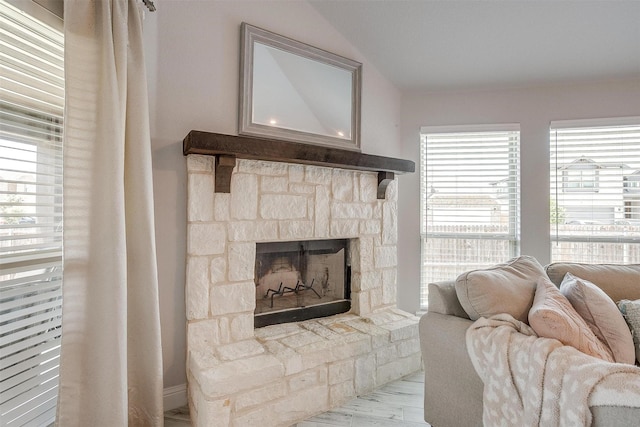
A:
[545,262,640,303]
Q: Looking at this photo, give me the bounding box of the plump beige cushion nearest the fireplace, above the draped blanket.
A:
[456,255,544,322]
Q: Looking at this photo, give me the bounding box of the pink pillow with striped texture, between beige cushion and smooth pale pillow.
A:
[529,277,613,362]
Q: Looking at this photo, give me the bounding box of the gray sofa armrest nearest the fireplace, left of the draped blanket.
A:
[419,310,484,427]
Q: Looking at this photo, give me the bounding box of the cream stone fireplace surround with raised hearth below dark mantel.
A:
[186,154,421,427]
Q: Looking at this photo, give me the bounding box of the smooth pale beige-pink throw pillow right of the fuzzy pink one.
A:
[560,273,636,365]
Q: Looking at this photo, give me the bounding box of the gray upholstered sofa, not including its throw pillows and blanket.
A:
[420,261,640,427]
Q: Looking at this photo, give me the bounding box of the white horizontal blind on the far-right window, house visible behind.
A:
[550,117,640,264]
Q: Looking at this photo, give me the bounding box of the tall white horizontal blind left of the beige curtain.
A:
[0,1,64,426]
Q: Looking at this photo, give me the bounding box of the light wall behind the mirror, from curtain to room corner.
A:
[145,0,400,388]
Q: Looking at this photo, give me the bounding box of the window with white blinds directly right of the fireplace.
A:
[420,125,520,307]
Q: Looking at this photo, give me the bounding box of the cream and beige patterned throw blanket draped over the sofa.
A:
[466,314,640,427]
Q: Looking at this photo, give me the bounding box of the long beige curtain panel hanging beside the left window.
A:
[57,0,163,427]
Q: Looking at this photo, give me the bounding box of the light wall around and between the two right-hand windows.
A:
[398,79,640,311]
